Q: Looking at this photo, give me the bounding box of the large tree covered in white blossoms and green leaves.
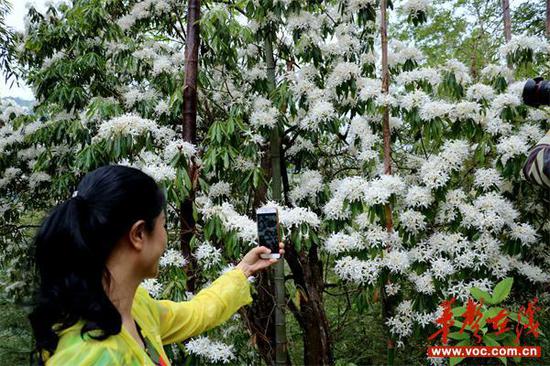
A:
[0,0,550,364]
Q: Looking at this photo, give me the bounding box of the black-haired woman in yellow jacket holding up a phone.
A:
[29,166,284,366]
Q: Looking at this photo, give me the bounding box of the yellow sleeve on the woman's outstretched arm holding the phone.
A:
[155,268,252,344]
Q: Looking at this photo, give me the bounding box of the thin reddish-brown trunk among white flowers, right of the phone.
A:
[380,0,395,365]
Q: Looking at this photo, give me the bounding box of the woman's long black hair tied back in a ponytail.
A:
[29,165,166,363]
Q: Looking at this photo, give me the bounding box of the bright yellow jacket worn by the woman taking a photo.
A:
[45,268,252,366]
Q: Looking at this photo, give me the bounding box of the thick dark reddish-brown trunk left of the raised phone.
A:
[180,0,200,292]
